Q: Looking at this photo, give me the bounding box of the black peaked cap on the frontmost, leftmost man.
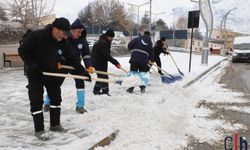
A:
[52,17,71,36]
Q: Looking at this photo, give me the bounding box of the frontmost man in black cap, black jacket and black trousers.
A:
[18,18,91,140]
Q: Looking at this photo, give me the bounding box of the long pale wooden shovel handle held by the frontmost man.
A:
[43,72,123,85]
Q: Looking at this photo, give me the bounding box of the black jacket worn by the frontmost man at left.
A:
[18,25,86,73]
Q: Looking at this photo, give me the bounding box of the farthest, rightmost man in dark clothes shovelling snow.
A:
[154,37,169,75]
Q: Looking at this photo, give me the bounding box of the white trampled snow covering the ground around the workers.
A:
[0,52,245,150]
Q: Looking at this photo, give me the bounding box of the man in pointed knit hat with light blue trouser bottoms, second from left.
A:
[44,19,94,114]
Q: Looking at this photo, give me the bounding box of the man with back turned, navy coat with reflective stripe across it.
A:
[127,31,154,93]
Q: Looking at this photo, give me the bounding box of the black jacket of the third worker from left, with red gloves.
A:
[91,35,119,71]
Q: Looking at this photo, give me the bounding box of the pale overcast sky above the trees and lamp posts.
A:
[52,0,250,33]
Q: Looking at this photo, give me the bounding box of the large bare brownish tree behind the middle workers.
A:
[78,0,130,32]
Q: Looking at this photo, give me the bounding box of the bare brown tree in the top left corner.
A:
[6,0,55,28]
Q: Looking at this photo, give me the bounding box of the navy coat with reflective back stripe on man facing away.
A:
[128,35,154,65]
